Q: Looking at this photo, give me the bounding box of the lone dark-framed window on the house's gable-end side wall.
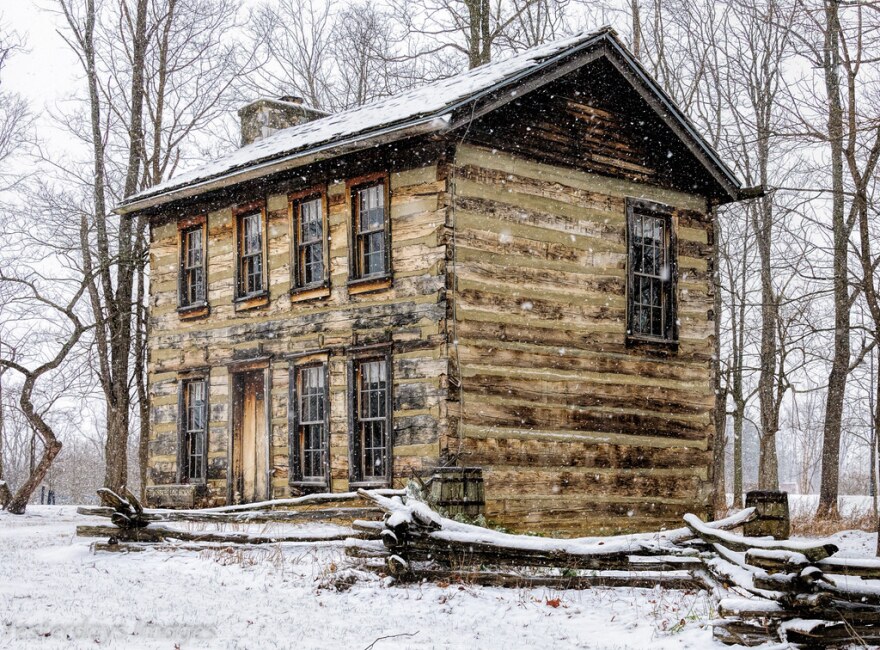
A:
[627,199,678,342]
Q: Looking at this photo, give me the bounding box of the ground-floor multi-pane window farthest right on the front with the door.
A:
[353,357,391,482]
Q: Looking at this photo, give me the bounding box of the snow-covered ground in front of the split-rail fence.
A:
[0,506,875,650]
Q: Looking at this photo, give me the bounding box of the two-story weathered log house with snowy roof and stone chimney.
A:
[117,28,744,534]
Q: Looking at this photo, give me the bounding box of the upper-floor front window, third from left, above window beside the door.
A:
[290,190,328,291]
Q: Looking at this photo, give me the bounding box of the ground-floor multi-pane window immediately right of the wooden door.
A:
[290,363,328,485]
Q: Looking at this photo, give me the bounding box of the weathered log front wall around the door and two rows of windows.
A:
[148,163,447,503]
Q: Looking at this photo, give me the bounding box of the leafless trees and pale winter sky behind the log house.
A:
[0,0,880,528]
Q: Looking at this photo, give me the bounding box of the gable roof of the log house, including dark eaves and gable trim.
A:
[115,27,742,214]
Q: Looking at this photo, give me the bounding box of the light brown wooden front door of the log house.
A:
[232,370,269,503]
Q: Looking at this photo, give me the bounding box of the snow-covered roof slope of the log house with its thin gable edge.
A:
[116,27,739,214]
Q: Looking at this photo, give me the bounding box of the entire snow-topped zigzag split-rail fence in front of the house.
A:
[77,490,880,647]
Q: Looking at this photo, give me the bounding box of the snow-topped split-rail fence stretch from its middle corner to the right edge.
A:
[347,491,880,647]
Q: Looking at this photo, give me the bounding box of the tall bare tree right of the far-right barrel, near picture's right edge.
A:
[793,0,877,516]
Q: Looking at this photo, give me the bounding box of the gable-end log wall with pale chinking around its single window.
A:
[448,142,715,533]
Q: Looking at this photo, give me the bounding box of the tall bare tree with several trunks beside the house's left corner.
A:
[56,0,243,489]
